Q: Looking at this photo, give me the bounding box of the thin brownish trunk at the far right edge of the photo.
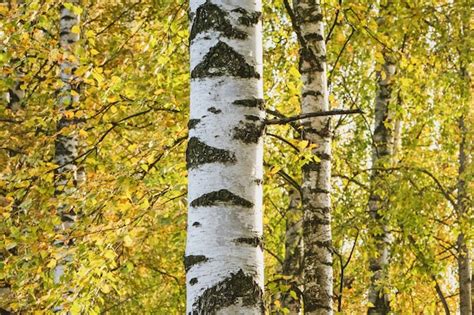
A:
[457,116,472,315]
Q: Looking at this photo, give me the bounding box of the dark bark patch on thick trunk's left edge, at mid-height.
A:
[186,137,237,169]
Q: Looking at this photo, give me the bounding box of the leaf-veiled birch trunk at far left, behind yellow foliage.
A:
[54,0,80,311]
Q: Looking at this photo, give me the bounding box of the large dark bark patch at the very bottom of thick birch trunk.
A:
[193,269,264,315]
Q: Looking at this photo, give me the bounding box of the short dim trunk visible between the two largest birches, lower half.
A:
[282,189,304,314]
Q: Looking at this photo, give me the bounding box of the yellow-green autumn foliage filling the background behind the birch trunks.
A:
[0,0,473,314]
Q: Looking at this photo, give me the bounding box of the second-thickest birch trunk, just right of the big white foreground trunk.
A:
[293,0,333,314]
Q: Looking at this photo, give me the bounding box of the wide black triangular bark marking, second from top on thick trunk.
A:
[191,41,260,79]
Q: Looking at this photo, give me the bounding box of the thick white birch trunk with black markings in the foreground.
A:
[184,0,264,314]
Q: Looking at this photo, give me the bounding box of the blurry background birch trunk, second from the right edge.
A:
[368,55,396,314]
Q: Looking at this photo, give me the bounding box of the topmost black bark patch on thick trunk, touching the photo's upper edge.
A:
[189,1,248,41]
